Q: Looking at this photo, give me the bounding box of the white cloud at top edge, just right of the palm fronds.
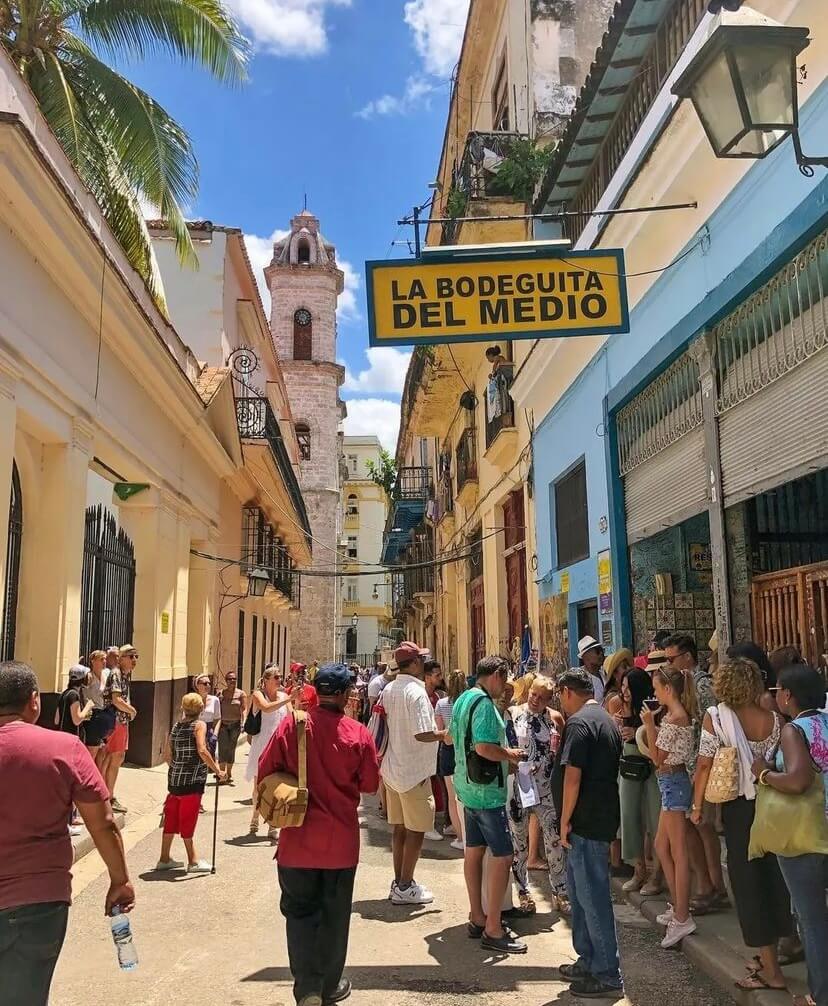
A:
[227,0,351,56]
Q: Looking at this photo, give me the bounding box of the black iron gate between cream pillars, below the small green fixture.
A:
[80,504,134,659]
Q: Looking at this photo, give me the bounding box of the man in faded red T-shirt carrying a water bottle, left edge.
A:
[0,661,135,1006]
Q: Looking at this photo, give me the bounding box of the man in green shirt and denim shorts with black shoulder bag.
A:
[451,657,526,954]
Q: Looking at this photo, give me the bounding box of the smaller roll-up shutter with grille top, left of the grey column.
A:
[616,352,707,544]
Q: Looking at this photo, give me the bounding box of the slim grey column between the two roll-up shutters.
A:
[690,333,731,653]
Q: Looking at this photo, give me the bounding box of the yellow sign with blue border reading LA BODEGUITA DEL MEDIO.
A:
[365,248,630,346]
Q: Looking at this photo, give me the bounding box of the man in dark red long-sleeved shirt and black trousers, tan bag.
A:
[258,664,379,1006]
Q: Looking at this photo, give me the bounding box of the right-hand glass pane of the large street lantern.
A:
[732,45,794,130]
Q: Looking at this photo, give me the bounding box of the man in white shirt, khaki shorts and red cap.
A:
[380,642,446,904]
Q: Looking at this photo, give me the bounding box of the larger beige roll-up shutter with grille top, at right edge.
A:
[713,230,828,506]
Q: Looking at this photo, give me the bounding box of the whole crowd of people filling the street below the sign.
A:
[0,634,828,1006]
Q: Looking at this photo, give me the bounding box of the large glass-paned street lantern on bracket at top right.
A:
[672,7,828,177]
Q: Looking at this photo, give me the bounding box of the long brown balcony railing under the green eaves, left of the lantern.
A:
[564,0,707,243]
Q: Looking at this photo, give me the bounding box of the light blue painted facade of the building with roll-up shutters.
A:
[533,72,828,662]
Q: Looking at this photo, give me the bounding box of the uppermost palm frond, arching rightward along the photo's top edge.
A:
[74,0,249,83]
